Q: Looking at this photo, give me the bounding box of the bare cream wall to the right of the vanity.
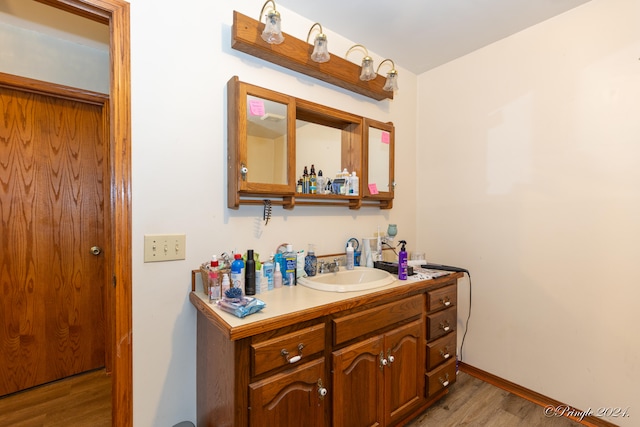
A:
[417,0,640,426]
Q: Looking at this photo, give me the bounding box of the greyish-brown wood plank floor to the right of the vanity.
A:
[407,372,580,427]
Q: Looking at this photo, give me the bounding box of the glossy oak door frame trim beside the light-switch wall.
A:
[36,0,133,427]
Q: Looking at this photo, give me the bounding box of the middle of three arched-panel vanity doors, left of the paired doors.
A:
[332,336,384,427]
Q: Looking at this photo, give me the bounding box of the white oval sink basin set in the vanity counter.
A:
[298,267,396,292]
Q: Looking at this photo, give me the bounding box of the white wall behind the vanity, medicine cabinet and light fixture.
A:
[130,0,416,427]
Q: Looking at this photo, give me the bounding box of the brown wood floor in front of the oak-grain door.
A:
[0,369,111,427]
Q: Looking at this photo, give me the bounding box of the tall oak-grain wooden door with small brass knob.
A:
[0,83,109,395]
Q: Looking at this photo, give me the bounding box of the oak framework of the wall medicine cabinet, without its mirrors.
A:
[227,76,394,209]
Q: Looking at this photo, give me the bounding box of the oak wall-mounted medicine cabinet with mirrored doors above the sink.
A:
[227,76,394,209]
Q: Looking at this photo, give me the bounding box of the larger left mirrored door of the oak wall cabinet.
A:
[227,77,295,208]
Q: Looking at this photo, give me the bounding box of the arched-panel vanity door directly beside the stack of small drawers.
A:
[384,319,425,425]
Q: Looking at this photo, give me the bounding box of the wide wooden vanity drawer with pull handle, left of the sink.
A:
[251,323,325,375]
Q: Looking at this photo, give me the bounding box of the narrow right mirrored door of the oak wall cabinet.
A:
[363,119,395,209]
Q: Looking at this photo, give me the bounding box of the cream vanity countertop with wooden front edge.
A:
[189,273,462,340]
